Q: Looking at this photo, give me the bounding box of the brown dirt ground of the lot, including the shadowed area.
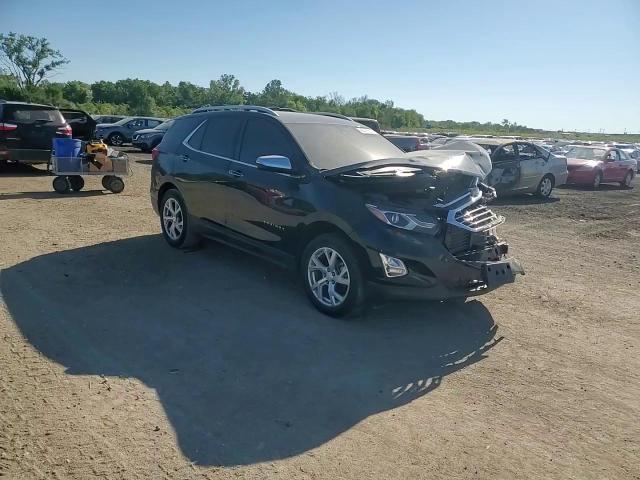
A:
[0,154,640,479]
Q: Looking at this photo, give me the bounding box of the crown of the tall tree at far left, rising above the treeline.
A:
[0,32,69,91]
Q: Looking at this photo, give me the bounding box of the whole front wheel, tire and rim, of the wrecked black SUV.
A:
[300,234,366,317]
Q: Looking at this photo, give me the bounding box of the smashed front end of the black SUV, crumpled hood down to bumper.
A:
[325,152,524,299]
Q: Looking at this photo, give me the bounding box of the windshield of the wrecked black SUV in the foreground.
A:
[286,123,405,170]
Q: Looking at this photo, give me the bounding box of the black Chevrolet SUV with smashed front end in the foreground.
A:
[151,106,523,316]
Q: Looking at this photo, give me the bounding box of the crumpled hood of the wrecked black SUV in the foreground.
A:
[322,157,484,209]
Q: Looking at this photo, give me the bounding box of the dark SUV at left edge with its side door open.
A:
[0,100,96,166]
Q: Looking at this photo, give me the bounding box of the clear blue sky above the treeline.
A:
[0,0,640,132]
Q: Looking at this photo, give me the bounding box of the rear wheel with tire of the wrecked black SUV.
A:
[160,189,201,248]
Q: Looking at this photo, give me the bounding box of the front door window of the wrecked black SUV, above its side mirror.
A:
[240,118,299,164]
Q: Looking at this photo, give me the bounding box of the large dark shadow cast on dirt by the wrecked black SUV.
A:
[0,235,501,465]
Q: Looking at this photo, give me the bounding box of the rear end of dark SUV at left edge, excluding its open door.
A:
[2,103,65,162]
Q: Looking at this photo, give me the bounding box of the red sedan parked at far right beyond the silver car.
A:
[565,145,636,188]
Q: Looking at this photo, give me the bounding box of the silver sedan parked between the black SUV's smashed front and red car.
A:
[468,138,568,198]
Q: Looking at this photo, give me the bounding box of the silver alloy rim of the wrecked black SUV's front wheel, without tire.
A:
[307,247,351,307]
